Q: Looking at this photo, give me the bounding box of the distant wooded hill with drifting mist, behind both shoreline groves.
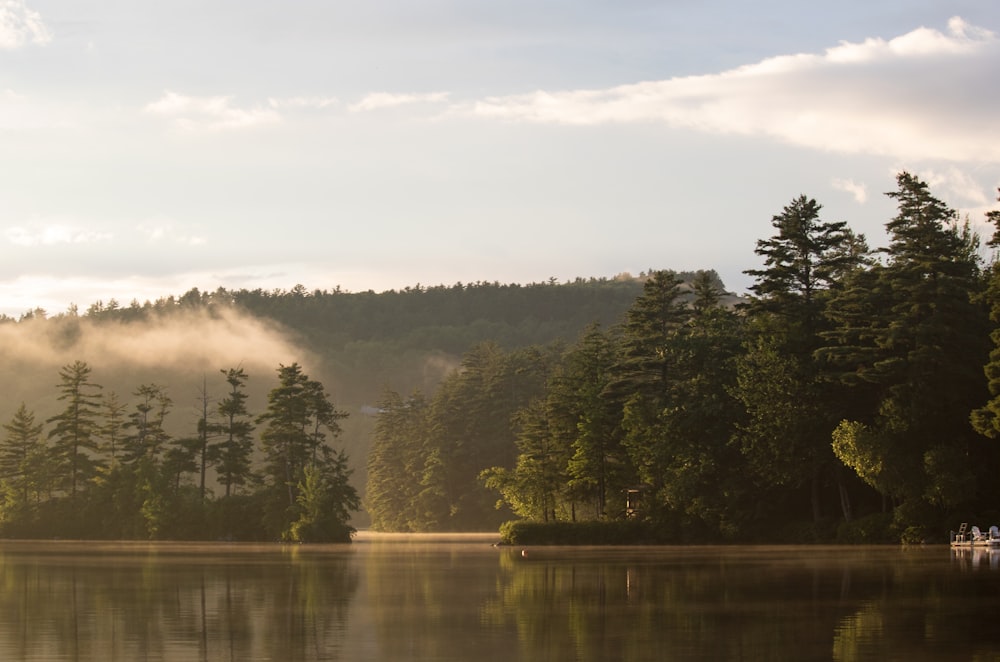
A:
[0,272,737,528]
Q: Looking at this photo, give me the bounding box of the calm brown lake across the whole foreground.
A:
[0,533,1000,662]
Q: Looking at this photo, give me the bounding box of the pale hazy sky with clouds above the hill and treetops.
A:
[0,0,1000,316]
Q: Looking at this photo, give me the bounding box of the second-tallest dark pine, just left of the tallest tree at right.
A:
[734,196,868,522]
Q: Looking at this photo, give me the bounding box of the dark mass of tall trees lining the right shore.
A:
[365,172,1000,542]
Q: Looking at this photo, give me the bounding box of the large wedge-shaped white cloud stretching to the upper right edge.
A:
[466,18,1000,162]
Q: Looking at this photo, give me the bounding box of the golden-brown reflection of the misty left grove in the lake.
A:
[0,543,357,660]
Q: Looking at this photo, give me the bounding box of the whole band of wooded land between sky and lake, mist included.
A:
[0,173,1000,542]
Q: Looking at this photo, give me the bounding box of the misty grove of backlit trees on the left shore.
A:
[0,361,360,542]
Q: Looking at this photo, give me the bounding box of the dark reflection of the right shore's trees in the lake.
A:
[476,546,1000,661]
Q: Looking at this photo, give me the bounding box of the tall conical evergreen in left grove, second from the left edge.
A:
[48,361,101,499]
